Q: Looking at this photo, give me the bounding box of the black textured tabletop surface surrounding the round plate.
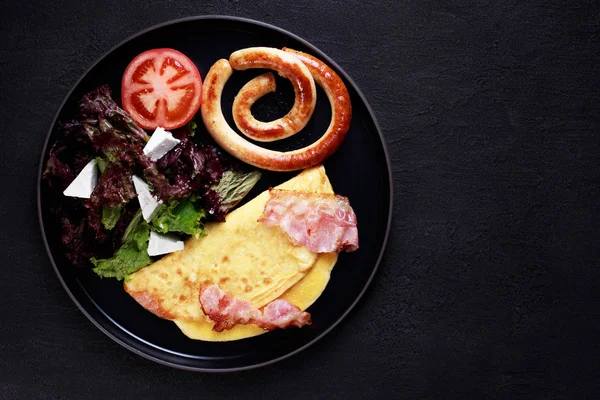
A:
[0,0,600,399]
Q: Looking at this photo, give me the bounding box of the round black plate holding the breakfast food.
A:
[38,16,392,371]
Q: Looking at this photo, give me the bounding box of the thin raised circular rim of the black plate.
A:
[36,14,394,373]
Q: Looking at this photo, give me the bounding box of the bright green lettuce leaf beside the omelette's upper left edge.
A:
[90,211,152,280]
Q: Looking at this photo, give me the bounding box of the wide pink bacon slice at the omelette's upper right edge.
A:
[258,189,358,253]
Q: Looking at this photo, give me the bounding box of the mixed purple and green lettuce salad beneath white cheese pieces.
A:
[42,85,260,280]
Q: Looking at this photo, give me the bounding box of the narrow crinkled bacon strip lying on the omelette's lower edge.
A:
[199,285,310,332]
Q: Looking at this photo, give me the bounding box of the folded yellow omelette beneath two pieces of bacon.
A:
[124,166,337,341]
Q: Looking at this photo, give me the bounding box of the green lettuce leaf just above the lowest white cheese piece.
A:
[151,198,206,237]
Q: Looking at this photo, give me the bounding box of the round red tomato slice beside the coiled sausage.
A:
[121,49,202,129]
